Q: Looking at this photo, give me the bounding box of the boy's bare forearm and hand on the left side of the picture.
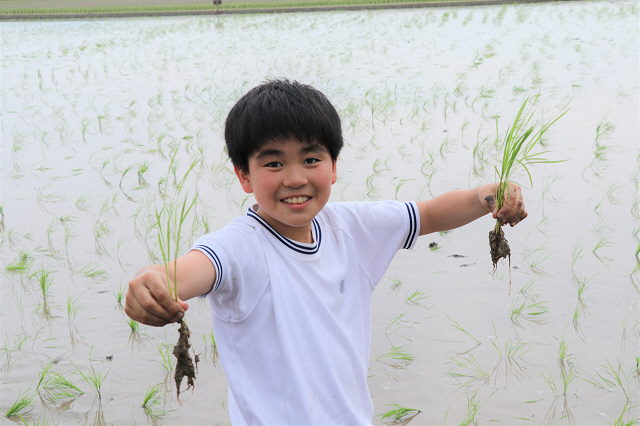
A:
[125,250,216,327]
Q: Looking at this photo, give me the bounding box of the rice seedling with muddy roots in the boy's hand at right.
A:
[487,95,567,288]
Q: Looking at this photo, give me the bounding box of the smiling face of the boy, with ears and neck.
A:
[234,137,337,243]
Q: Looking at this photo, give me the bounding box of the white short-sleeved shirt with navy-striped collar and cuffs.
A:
[193,201,420,425]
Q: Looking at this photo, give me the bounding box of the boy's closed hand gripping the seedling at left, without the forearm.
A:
[124,268,189,327]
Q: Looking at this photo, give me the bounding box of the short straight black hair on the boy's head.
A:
[224,79,343,172]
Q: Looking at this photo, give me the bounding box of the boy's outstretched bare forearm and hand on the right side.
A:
[417,182,527,235]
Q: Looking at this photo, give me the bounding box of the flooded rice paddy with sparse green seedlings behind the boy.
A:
[0,0,640,425]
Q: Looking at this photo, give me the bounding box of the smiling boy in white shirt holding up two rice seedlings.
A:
[126,80,527,425]
